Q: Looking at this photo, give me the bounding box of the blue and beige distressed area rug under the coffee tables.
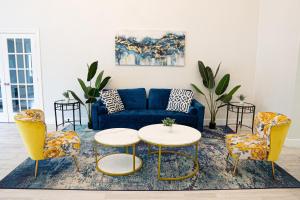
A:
[0,126,300,190]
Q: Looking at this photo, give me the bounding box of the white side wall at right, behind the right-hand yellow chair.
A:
[255,0,300,144]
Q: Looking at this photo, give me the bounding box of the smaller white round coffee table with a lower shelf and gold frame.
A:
[94,128,142,176]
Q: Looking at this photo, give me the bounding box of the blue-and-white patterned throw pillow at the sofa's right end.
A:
[167,89,194,113]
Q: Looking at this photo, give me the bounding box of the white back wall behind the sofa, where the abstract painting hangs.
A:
[0,0,259,122]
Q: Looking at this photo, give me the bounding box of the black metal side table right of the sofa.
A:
[226,102,255,133]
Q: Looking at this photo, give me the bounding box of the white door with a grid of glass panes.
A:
[0,33,43,122]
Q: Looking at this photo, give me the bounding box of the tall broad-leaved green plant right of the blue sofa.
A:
[191,61,241,128]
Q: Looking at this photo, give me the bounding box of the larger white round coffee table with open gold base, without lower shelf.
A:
[139,124,201,180]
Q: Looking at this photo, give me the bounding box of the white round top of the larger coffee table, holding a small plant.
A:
[139,124,201,147]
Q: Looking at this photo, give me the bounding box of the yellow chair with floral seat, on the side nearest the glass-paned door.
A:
[14,109,80,177]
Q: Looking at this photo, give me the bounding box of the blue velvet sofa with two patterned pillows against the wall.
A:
[92,88,204,131]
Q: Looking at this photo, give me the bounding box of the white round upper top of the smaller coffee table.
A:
[95,128,140,147]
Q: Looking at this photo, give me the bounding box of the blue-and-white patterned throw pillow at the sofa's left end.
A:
[100,89,125,114]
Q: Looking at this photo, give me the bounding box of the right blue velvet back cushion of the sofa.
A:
[148,88,171,110]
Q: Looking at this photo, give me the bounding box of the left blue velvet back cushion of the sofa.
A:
[118,88,147,110]
